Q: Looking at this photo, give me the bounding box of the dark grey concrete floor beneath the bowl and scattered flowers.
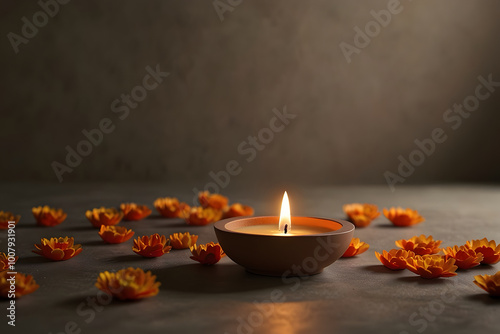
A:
[0,184,500,334]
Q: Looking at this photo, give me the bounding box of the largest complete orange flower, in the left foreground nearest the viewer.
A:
[95,267,161,300]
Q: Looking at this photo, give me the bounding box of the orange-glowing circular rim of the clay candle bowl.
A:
[214,216,356,238]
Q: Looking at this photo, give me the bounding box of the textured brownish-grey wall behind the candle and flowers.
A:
[0,0,500,184]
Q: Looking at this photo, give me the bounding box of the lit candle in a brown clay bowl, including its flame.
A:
[214,192,354,277]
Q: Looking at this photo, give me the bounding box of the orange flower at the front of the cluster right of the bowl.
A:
[406,255,458,278]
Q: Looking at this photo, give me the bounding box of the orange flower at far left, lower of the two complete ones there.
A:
[33,237,82,261]
